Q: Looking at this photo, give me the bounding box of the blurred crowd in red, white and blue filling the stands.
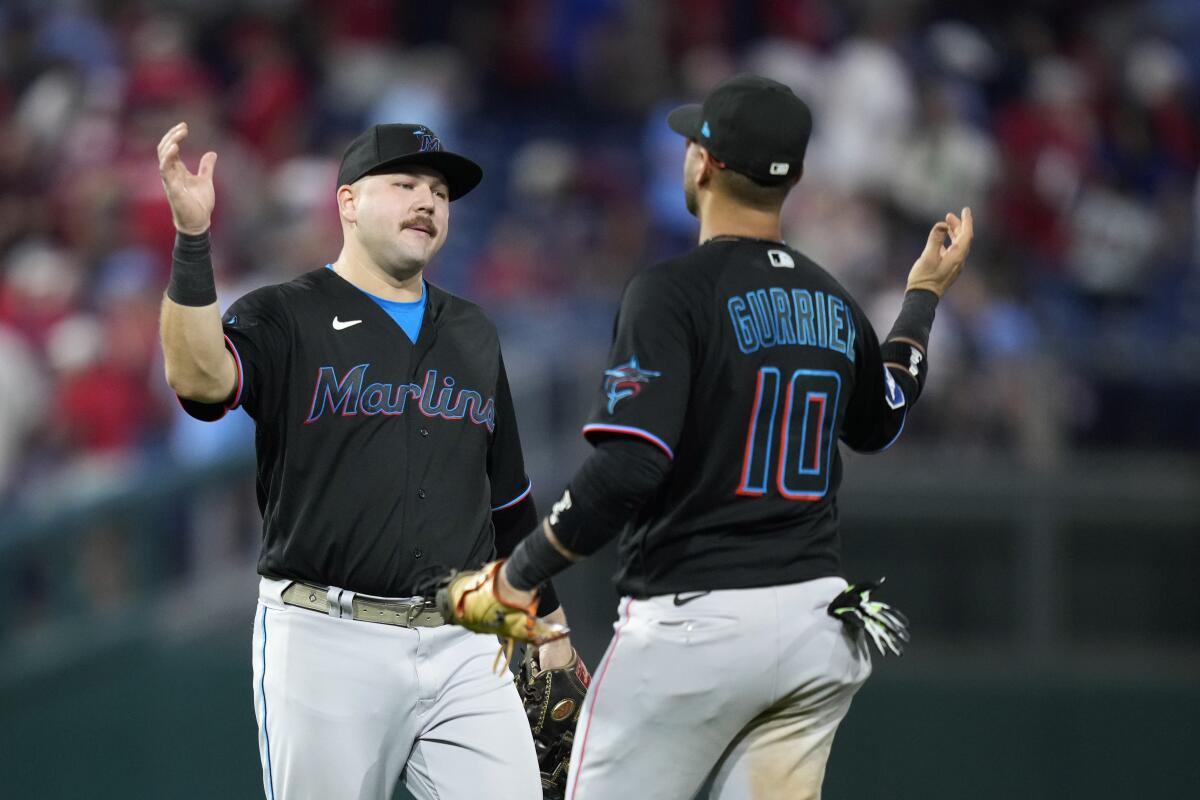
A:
[0,0,1200,505]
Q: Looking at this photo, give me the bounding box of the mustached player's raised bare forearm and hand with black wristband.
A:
[158,122,238,403]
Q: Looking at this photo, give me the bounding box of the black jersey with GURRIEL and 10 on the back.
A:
[583,237,906,596]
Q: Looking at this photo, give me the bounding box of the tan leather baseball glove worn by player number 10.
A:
[437,560,568,644]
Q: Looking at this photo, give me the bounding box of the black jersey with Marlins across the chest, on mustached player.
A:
[184,269,532,596]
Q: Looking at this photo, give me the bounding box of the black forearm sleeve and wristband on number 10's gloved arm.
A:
[506,437,671,589]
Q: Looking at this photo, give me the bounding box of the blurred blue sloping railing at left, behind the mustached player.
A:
[0,453,257,690]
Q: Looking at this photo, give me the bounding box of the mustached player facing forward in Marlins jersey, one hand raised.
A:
[158,124,587,800]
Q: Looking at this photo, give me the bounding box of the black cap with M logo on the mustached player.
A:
[337,122,484,200]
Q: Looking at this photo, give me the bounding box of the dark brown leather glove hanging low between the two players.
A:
[517,646,592,800]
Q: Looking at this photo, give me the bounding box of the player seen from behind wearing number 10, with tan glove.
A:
[439,76,972,800]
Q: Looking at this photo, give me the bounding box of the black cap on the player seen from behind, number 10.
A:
[667,76,812,185]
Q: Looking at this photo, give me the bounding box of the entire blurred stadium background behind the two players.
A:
[0,0,1200,800]
